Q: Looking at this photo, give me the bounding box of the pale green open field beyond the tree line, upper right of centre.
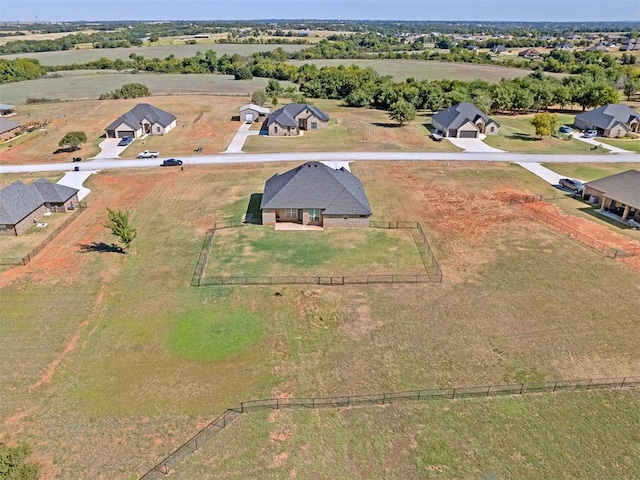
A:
[291,59,564,83]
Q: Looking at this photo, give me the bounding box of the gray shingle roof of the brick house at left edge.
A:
[0,178,79,225]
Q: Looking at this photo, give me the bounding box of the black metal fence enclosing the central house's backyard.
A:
[191,221,442,287]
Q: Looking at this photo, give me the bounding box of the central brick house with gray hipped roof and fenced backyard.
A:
[260,162,371,227]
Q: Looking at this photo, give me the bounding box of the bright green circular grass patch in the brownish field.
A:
[169,308,262,361]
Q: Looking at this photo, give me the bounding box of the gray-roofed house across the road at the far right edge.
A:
[573,103,640,138]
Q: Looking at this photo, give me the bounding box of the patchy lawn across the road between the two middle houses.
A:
[243,100,460,153]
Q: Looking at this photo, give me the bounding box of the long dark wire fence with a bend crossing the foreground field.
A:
[140,377,640,480]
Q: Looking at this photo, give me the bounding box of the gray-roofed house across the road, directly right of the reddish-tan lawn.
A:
[431,102,500,138]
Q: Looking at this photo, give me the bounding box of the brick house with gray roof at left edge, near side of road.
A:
[0,178,79,235]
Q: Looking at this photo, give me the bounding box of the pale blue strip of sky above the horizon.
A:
[0,0,640,22]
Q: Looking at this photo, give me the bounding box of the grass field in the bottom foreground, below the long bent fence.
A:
[175,391,640,480]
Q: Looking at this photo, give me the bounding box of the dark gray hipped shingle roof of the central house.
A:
[260,162,371,215]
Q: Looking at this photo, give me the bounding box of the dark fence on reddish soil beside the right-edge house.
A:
[509,195,640,258]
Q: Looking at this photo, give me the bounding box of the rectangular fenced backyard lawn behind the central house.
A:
[205,225,426,282]
